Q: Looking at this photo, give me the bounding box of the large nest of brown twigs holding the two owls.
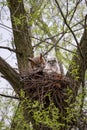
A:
[22,69,71,107]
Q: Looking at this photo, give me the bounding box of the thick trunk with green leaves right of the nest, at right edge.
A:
[66,27,87,93]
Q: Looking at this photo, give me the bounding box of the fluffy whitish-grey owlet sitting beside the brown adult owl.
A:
[45,57,61,74]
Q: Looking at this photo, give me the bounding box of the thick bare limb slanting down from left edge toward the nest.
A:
[0,57,22,94]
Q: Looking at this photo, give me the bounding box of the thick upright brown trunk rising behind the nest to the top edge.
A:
[7,0,33,74]
